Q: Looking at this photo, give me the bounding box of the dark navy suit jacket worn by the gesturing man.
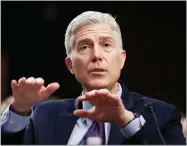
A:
[1,82,186,145]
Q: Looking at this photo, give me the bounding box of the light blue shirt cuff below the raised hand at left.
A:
[1,105,33,132]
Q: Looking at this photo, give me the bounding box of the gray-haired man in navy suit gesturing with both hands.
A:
[1,11,185,145]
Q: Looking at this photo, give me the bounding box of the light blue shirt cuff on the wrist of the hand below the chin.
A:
[120,115,146,139]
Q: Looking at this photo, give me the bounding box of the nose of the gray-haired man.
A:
[92,45,103,62]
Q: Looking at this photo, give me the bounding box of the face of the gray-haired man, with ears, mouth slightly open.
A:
[66,23,126,91]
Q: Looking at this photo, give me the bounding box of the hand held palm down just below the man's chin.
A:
[74,89,134,127]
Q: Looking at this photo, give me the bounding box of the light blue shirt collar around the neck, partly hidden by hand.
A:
[77,83,122,123]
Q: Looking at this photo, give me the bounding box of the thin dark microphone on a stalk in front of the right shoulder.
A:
[145,103,166,145]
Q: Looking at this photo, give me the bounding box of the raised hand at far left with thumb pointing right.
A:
[11,77,60,112]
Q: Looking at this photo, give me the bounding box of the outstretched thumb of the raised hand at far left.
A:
[41,83,60,97]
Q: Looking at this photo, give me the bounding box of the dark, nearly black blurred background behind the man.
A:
[1,1,186,112]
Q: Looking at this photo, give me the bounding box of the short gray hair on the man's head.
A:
[64,11,123,57]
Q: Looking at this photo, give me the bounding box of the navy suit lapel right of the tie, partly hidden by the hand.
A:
[108,82,134,145]
